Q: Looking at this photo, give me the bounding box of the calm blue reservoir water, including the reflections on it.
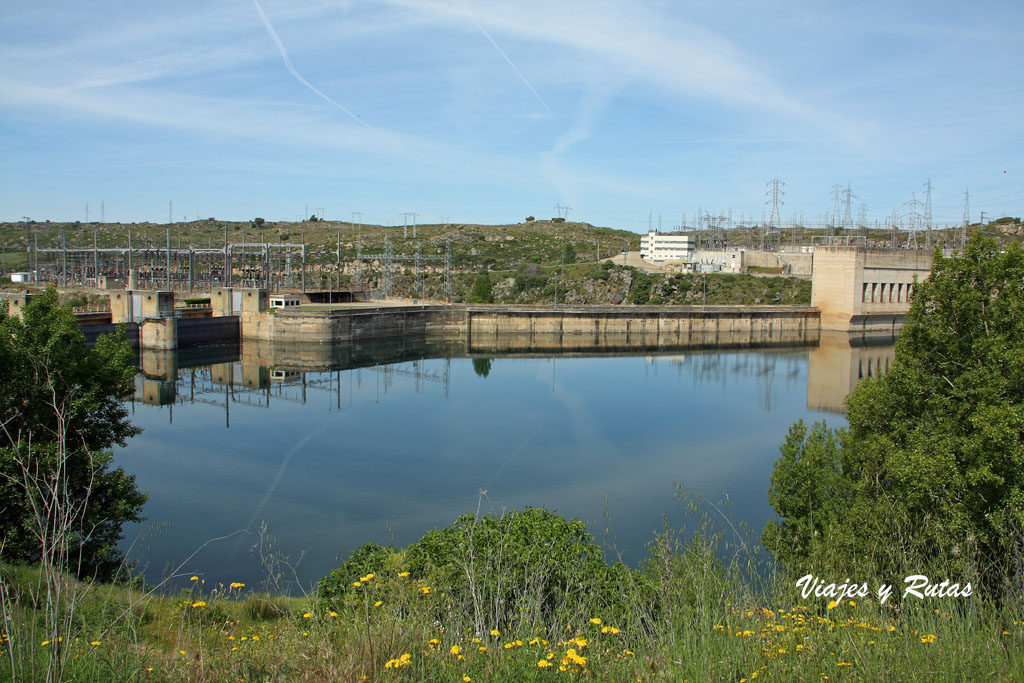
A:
[116,335,892,590]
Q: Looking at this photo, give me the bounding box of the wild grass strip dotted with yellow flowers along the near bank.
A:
[0,501,1024,681]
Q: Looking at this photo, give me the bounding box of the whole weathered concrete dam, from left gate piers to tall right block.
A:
[0,247,932,351]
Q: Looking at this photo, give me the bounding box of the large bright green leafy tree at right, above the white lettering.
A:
[763,234,1024,586]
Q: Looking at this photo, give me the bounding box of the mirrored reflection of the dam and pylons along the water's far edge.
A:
[134,323,893,424]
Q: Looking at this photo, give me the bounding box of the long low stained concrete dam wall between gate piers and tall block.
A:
[241,305,819,351]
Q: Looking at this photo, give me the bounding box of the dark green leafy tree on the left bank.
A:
[0,289,145,579]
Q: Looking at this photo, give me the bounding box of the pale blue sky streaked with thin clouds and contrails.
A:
[0,0,1024,231]
